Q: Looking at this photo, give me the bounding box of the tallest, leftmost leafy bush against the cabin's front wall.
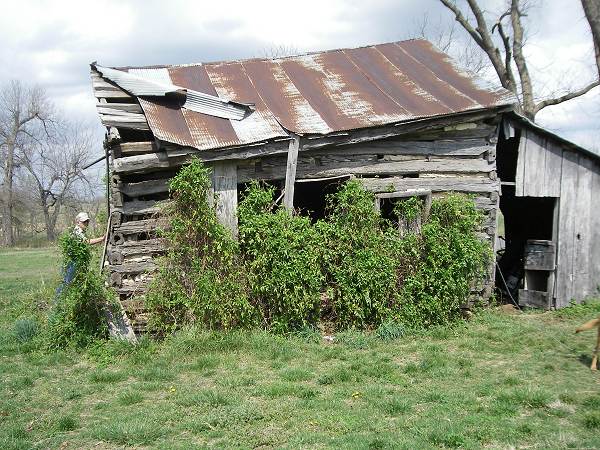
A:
[146,160,256,333]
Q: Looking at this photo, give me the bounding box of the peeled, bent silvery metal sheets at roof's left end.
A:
[90,62,254,120]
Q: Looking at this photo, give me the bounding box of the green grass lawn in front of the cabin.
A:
[0,250,600,449]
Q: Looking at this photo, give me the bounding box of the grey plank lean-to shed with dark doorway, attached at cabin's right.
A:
[497,114,600,308]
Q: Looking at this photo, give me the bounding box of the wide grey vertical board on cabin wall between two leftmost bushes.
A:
[213,161,237,237]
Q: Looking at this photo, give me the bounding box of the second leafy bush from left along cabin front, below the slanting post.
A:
[239,183,323,332]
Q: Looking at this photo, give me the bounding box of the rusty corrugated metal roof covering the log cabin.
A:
[94,39,516,150]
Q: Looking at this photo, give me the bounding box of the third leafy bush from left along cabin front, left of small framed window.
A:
[317,180,397,328]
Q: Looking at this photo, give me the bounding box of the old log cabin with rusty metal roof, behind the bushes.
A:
[91,40,591,325]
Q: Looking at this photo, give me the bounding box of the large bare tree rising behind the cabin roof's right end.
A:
[440,0,600,120]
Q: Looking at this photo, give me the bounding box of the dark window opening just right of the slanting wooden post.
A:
[294,176,350,222]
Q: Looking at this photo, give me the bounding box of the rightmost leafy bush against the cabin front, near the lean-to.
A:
[397,194,491,327]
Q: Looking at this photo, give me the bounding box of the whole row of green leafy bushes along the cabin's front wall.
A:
[147,161,489,334]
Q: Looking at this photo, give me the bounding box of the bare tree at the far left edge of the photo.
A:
[0,81,52,246]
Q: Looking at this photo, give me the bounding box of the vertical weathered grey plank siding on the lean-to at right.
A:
[515,129,600,308]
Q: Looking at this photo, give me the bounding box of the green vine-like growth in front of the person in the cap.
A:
[45,232,110,348]
